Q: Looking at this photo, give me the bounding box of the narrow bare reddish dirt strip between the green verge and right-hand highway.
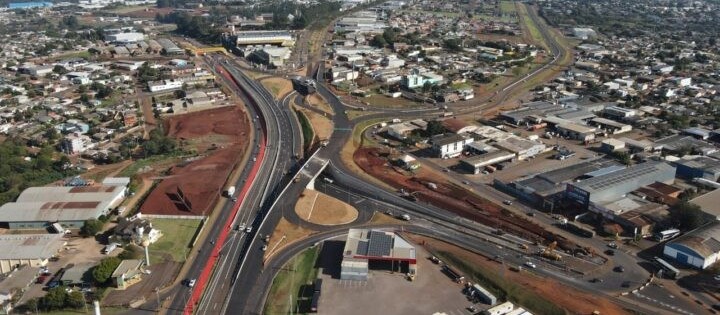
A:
[408,235,627,314]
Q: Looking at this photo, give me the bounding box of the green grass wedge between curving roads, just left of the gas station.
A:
[263,246,320,314]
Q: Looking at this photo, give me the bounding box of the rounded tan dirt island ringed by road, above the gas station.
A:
[295,189,358,225]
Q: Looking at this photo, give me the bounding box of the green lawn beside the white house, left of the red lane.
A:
[149,219,200,263]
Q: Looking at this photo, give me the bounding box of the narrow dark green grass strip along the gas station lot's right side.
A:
[436,251,565,314]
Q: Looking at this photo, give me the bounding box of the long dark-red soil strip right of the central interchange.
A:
[353,148,576,250]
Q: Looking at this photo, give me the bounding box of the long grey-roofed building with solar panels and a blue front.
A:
[565,161,675,214]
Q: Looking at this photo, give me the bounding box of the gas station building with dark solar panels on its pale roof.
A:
[340,229,417,281]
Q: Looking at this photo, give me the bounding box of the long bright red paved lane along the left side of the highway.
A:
[184,66,267,315]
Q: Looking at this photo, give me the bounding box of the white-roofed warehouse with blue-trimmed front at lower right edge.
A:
[663,221,720,269]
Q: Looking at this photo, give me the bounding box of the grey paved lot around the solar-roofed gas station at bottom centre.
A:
[318,247,484,315]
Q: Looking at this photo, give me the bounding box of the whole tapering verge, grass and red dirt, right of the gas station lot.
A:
[407,235,628,314]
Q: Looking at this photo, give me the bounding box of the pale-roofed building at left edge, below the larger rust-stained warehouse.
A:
[0,234,66,274]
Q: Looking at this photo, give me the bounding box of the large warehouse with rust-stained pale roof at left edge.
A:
[0,186,126,229]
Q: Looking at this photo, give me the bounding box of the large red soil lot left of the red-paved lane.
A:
[140,107,250,215]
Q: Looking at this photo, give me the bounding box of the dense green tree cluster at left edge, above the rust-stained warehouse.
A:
[0,138,77,204]
